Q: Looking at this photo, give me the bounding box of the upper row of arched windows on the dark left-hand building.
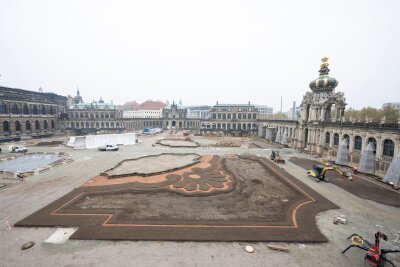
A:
[0,103,57,115]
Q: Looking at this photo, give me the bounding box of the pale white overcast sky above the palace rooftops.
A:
[0,0,400,111]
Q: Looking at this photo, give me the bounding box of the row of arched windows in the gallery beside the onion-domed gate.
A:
[325,132,394,157]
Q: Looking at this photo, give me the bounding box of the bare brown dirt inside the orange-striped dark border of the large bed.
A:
[76,158,301,222]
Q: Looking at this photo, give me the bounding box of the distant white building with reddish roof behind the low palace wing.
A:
[121,100,165,119]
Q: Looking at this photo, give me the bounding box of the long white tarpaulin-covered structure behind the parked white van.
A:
[67,133,137,149]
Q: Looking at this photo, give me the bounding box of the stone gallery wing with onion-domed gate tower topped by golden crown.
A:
[258,57,400,176]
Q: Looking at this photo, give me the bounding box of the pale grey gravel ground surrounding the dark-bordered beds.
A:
[0,135,400,266]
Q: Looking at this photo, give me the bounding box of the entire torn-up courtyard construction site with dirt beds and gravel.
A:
[0,131,400,266]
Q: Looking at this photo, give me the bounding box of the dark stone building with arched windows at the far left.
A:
[0,87,67,141]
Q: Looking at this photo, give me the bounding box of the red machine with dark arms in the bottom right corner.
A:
[342,231,400,267]
